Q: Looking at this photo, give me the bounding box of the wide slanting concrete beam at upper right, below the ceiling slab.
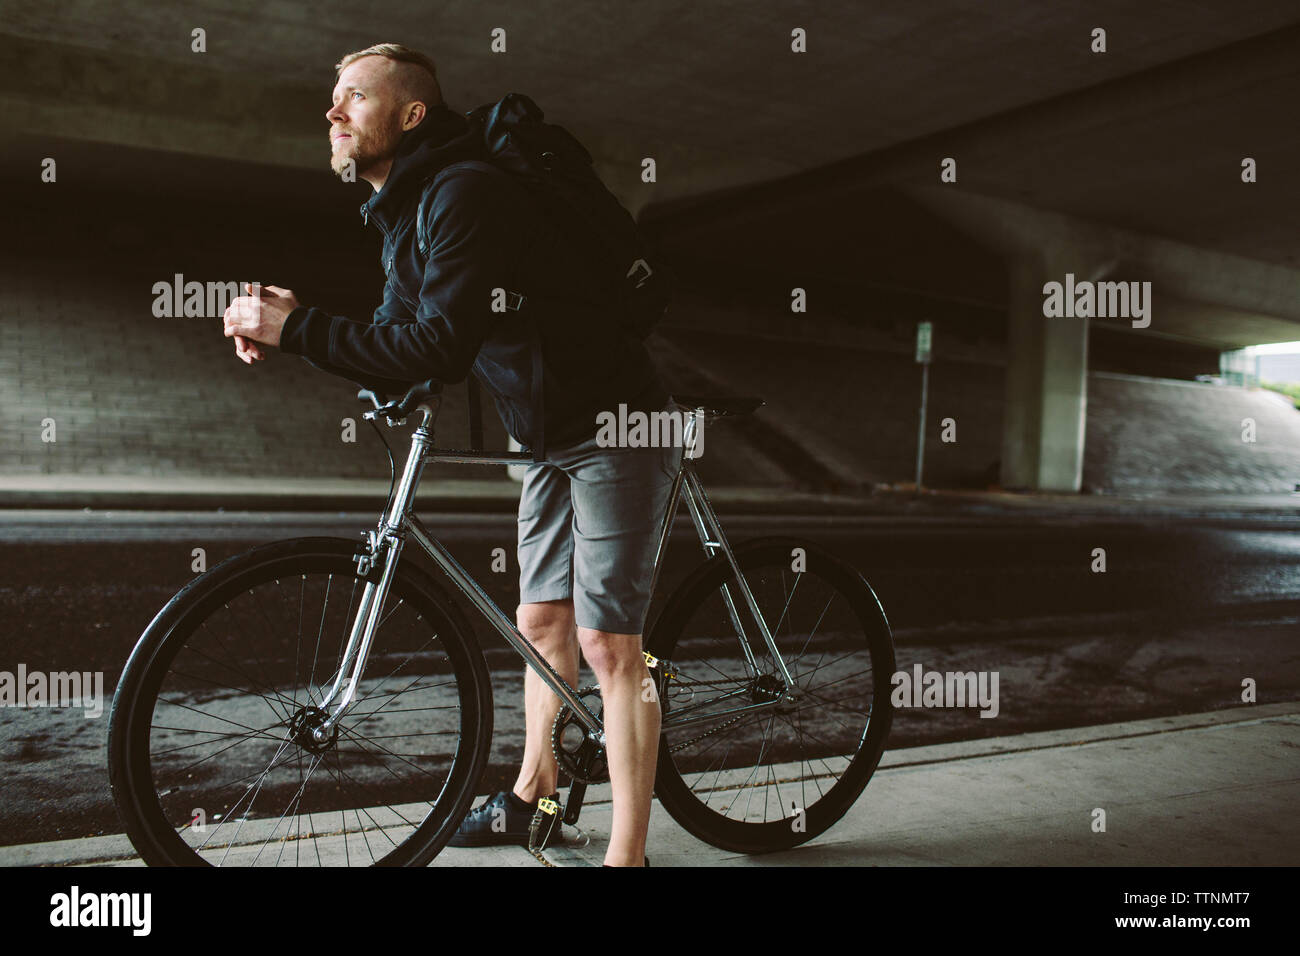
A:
[655,18,1300,268]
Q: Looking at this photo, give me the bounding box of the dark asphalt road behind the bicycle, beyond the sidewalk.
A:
[0,511,1300,844]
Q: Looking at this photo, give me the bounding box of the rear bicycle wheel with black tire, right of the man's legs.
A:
[646,537,894,853]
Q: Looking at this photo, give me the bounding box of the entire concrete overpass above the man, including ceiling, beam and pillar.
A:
[0,0,1300,490]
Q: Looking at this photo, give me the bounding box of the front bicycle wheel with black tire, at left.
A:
[108,537,493,866]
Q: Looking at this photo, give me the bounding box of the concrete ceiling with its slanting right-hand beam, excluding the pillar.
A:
[0,0,1300,348]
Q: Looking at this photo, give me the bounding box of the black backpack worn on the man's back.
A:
[416,92,673,339]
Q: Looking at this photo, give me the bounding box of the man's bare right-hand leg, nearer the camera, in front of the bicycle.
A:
[577,627,659,866]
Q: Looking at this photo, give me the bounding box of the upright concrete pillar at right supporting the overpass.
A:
[1000,251,1088,492]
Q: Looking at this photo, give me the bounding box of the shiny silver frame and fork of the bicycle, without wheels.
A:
[313,398,794,747]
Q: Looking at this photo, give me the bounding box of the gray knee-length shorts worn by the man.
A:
[519,411,681,633]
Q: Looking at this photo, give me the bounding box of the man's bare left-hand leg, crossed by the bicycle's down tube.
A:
[514,598,577,803]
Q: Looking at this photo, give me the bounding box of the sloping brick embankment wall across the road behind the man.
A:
[0,255,1300,492]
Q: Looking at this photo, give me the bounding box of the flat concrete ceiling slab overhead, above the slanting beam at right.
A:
[10,0,1300,200]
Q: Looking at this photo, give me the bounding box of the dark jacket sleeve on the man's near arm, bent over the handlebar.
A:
[281,168,530,382]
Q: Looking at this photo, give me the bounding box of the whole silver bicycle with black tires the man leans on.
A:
[108,381,894,866]
